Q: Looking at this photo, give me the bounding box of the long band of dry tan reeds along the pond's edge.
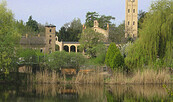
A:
[29,68,172,85]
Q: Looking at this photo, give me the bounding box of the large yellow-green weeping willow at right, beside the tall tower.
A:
[125,0,173,68]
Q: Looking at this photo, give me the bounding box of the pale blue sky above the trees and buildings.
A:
[0,0,156,31]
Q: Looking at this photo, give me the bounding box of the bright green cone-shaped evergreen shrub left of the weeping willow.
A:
[105,43,124,68]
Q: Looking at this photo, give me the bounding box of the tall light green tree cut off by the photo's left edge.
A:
[0,2,20,72]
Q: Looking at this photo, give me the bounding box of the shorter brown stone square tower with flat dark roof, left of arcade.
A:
[45,24,56,53]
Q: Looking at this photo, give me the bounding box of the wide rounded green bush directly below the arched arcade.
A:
[46,51,85,70]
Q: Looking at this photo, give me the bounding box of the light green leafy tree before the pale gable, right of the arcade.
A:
[79,28,105,58]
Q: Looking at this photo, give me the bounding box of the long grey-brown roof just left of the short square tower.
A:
[20,36,46,45]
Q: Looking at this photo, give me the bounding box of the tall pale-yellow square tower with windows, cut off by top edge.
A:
[125,0,138,38]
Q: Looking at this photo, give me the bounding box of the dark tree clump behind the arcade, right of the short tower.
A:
[58,18,82,42]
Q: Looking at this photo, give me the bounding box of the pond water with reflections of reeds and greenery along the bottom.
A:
[0,84,173,102]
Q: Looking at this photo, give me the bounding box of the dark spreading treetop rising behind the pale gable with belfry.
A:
[85,12,115,29]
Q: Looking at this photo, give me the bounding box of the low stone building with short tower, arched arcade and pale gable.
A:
[20,20,109,53]
